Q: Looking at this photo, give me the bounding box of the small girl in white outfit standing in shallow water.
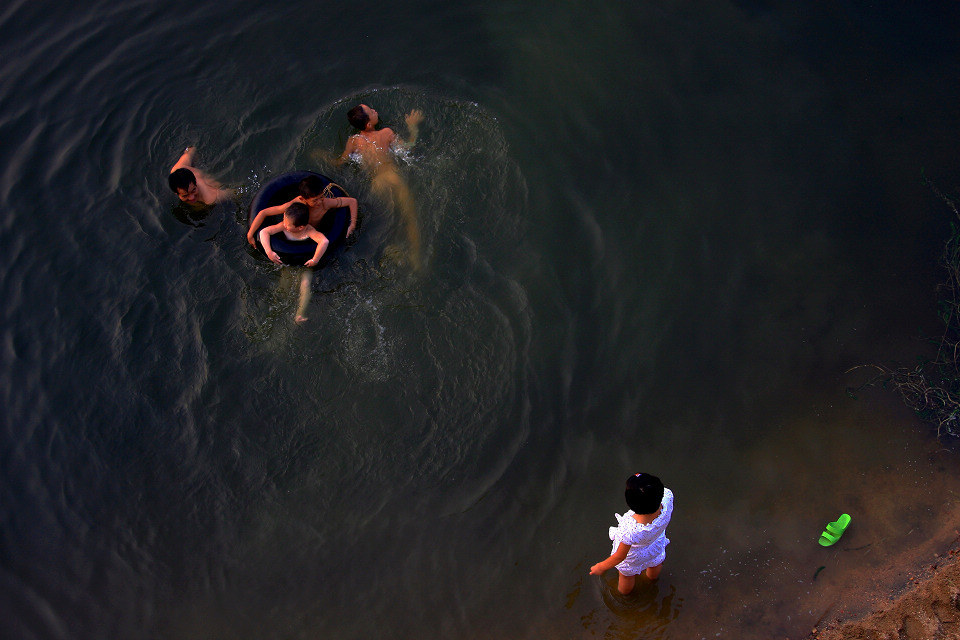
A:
[590,473,673,595]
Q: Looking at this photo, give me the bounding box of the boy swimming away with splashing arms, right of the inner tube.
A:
[337,104,423,269]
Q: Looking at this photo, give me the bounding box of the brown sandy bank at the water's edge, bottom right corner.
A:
[807,532,960,640]
